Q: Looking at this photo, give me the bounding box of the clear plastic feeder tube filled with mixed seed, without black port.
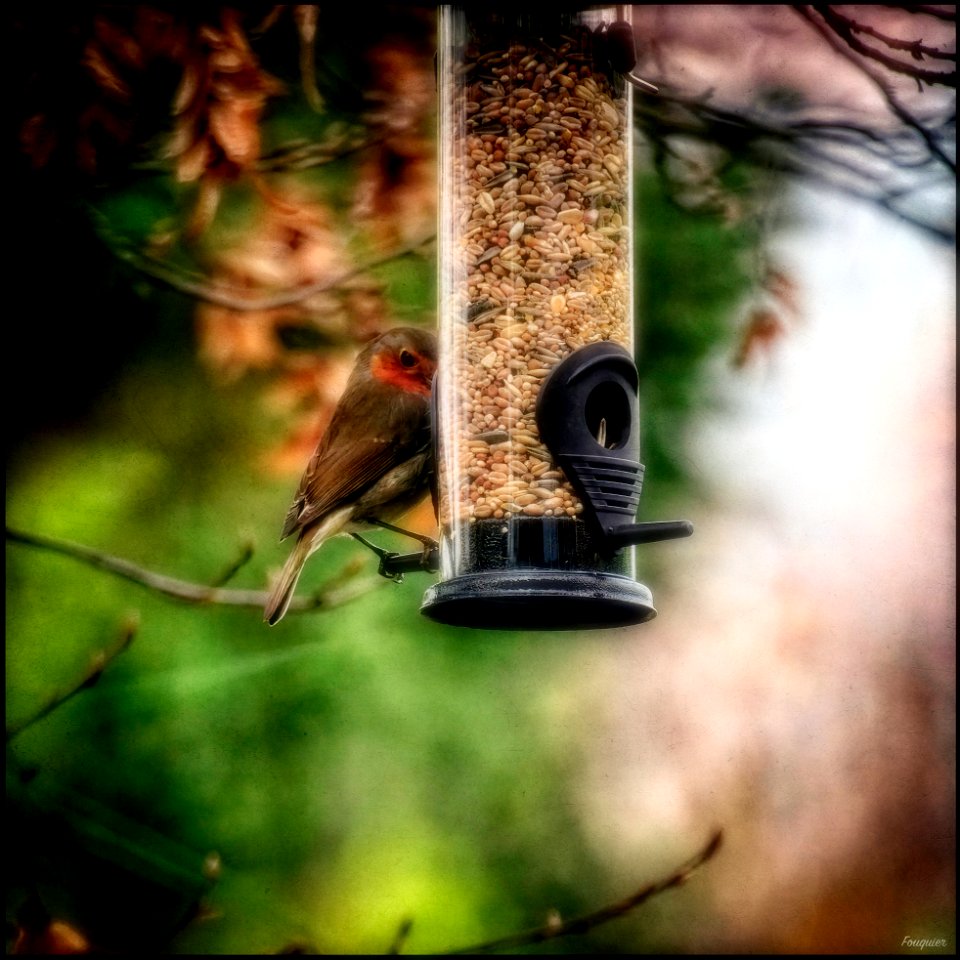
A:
[424,6,645,632]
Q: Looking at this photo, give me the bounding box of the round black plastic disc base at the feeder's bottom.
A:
[420,570,657,630]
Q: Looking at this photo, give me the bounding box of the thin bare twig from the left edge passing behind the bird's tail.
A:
[6,527,386,613]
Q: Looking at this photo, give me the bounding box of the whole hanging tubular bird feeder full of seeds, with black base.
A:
[421,5,692,629]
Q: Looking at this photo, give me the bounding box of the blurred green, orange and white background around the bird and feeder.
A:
[6,4,956,954]
